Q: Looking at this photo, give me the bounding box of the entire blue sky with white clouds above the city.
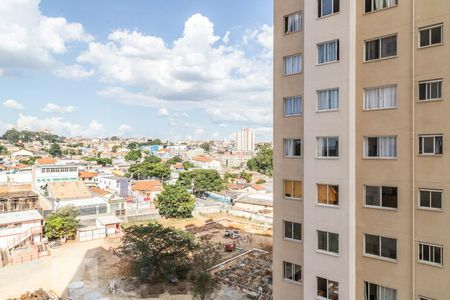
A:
[0,0,273,141]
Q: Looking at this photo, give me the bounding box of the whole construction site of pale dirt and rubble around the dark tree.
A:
[0,214,272,300]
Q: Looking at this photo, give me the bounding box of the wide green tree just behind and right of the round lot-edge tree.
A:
[178,169,226,195]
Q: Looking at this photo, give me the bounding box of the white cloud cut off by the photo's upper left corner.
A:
[0,0,93,70]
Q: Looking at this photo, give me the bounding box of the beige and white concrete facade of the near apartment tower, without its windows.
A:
[273,0,450,300]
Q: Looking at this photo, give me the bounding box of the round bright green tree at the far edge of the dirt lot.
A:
[155,184,195,219]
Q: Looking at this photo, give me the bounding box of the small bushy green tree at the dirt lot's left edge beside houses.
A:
[44,206,80,239]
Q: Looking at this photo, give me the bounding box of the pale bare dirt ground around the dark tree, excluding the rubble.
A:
[0,214,272,300]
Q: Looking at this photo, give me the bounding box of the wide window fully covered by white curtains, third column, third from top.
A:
[364,85,397,110]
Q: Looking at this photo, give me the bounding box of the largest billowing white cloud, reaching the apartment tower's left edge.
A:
[77,14,273,126]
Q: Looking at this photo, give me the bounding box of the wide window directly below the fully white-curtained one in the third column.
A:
[364,136,397,158]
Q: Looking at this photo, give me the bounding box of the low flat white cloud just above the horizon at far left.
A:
[10,114,105,137]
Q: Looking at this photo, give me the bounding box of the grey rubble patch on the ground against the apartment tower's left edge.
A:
[213,251,272,295]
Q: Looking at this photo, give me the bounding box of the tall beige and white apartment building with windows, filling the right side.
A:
[273,0,450,300]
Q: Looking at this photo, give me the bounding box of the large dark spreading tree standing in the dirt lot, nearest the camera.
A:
[119,223,196,282]
